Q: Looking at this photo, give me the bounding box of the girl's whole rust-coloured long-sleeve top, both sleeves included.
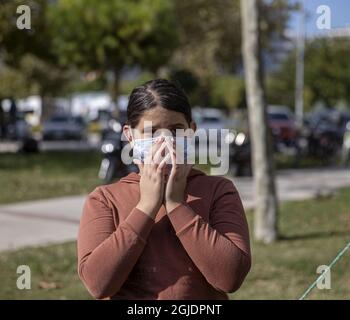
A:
[78,169,251,299]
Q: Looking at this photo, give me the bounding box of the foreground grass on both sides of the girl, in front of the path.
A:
[0,188,350,299]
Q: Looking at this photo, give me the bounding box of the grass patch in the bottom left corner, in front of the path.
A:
[0,242,90,299]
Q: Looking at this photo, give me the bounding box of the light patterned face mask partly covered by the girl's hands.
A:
[133,131,194,164]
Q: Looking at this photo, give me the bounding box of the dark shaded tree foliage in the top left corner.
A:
[0,0,77,116]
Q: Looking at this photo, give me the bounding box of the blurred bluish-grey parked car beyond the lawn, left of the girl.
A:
[43,114,86,140]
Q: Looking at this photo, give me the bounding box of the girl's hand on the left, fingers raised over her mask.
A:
[134,137,168,220]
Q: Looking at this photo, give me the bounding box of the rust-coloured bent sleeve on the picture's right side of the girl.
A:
[168,179,251,293]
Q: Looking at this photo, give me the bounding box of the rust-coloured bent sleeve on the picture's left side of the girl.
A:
[78,188,154,299]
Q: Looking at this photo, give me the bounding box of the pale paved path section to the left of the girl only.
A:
[0,196,85,250]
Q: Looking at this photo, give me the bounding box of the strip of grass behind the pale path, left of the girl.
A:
[0,151,101,203]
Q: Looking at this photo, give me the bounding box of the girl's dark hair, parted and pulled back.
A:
[126,79,192,128]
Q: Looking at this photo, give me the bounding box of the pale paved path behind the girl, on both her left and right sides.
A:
[0,169,350,250]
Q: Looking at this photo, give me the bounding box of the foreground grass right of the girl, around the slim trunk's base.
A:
[231,188,350,299]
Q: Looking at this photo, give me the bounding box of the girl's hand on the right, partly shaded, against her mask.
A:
[164,141,193,212]
